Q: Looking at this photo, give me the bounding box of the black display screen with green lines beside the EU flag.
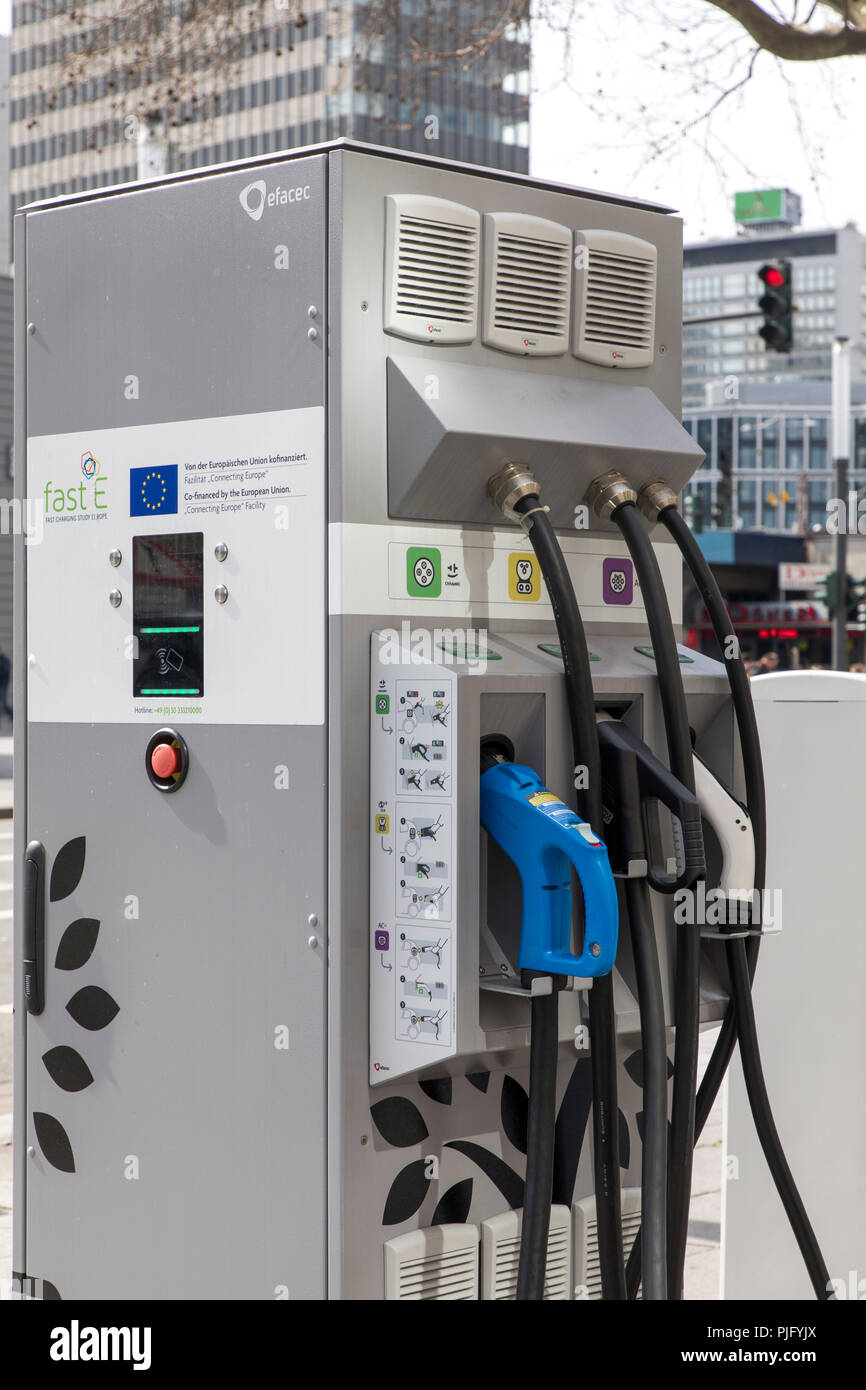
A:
[132,531,204,699]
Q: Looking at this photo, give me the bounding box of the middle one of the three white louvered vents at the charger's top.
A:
[481,213,571,357]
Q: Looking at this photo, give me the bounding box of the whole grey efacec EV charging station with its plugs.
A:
[14,142,850,1300]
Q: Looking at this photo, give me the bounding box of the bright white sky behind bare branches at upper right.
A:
[530,0,866,242]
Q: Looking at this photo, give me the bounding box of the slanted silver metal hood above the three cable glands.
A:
[388,353,702,530]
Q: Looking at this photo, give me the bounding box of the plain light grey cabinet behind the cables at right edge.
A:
[723,671,866,1301]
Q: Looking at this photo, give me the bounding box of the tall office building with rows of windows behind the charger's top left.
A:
[10,0,530,211]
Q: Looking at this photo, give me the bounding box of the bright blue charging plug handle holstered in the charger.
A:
[481,762,619,977]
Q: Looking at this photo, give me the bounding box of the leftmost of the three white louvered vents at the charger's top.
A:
[385,195,481,343]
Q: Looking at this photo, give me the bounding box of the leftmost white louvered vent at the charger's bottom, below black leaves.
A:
[385,1225,478,1302]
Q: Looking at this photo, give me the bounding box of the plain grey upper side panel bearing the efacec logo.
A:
[26,156,325,435]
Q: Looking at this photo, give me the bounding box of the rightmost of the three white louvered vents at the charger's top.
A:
[574,231,657,367]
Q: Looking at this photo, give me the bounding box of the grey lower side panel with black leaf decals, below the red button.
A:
[26,724,327,1298]
